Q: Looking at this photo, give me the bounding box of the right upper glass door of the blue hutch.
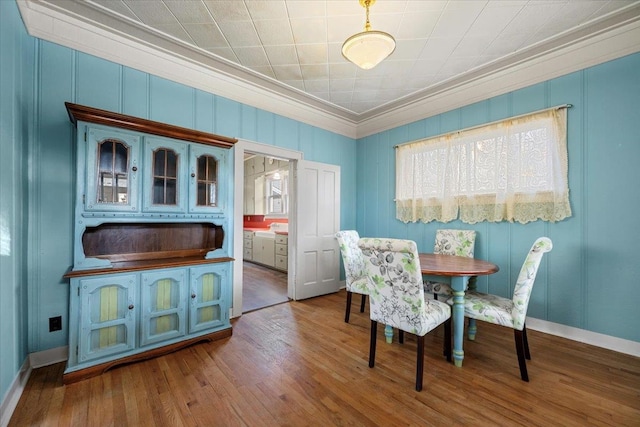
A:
[189,145,229,213]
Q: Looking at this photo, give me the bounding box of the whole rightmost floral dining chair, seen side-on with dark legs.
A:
[447,237,553,381]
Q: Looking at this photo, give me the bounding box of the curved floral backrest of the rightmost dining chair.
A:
[511,237,553,331]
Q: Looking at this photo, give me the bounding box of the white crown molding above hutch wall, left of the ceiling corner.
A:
[17,0,357,138]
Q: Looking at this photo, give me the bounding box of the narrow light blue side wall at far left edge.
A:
[0,1,35,408]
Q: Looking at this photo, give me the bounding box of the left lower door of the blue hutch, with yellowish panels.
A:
[78,274,137,363]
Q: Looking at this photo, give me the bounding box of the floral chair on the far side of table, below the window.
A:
[424,230,476,299]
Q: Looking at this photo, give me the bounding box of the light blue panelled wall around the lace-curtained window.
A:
[356,54,640,341]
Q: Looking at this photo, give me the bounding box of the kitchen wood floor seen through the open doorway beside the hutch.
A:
[242,261,289,313]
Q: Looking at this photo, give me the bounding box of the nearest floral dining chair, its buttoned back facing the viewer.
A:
[358,239,451,391]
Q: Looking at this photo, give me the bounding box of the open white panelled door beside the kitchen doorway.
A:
[290,160,340,300]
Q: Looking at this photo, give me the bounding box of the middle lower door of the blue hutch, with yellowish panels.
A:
[140,269,188,345]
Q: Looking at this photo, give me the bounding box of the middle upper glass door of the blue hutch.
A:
[143,137,187,213]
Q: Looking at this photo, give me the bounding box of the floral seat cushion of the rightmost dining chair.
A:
[447,291,514,328]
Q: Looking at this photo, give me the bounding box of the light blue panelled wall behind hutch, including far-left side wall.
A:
[0,1,356,404]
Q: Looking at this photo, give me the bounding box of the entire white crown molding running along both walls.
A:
[17,0,640,138]
